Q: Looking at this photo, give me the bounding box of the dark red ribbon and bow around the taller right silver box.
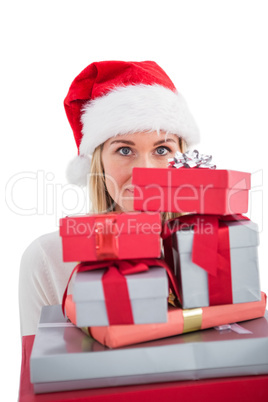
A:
[162,214,249,306]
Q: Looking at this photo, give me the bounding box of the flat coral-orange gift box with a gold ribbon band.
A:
[66,292,266,348]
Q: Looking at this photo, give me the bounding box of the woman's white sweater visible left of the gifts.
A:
[19,231,77,336]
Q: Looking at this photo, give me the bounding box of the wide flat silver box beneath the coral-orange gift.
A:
[30,306,268,393]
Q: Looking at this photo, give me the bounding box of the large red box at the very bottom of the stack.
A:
[18,335,268,402]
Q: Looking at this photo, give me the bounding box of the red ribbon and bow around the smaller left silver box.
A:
[62,258,180,325]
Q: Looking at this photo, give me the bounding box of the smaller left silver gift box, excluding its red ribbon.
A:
[73,267,168,327]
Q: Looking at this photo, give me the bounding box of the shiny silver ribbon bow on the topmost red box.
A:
[168,149,216,169]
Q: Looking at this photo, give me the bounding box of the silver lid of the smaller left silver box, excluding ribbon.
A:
[73,267,168,303]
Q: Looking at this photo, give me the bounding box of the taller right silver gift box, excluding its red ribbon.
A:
[172,220,261,309]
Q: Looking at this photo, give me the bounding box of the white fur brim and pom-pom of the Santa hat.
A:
[67,85,199,186]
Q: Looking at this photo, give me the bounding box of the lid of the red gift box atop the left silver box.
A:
[60,212,161,237]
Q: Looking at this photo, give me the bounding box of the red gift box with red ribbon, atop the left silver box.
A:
[60,213,161,262]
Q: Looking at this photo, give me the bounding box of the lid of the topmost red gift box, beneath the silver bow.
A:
[132,167,251,190]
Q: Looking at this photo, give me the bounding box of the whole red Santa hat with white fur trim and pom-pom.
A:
[64,61,199,185]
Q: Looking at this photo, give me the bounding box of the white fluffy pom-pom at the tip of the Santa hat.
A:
[66,155,91,186]
